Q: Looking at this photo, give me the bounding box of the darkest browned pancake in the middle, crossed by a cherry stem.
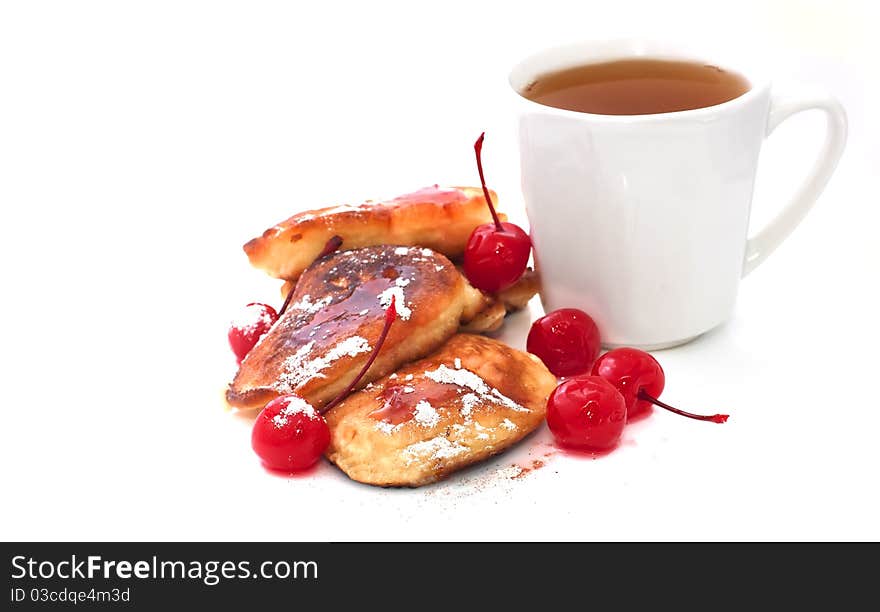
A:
[226,246,482,409]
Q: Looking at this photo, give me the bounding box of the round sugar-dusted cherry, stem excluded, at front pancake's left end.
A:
[251,395,330,472]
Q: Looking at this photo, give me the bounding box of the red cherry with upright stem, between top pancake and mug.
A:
[464,132,532,293]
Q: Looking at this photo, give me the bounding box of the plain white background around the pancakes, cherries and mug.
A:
[0,0,880,540]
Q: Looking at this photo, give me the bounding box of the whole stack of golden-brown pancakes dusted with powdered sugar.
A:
[227,186,556,486]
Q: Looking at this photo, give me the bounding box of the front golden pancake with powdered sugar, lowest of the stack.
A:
[325,334,556,487]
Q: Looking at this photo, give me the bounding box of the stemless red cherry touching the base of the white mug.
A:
[526,308,601,377]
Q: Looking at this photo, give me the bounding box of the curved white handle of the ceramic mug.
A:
[742,88,846,277]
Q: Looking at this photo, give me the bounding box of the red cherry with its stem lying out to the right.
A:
[592,348,729,423]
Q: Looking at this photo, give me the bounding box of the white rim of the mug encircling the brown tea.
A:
[507,38,769,123]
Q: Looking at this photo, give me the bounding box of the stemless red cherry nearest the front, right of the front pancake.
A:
[547,376,626,451]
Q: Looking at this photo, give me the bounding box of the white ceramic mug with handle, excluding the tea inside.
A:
[509,40,846,349]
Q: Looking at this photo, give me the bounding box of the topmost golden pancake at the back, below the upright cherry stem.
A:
[244,185,503,280]
